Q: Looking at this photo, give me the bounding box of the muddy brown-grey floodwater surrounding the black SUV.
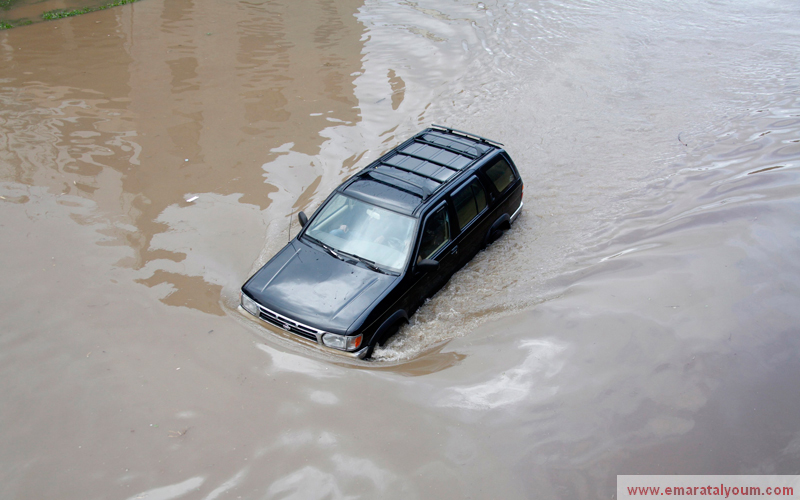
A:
[0,0,800,500]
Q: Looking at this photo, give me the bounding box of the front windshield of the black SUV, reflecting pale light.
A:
[305,193,416,271]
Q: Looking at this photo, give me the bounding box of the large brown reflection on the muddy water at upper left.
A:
[0,2,361,314]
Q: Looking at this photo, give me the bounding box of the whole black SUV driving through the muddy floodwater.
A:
[241,125,522,358]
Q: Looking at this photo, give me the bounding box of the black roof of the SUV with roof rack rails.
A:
[339,125,502,215]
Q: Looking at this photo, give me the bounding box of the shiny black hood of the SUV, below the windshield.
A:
[242,240,397,333]
